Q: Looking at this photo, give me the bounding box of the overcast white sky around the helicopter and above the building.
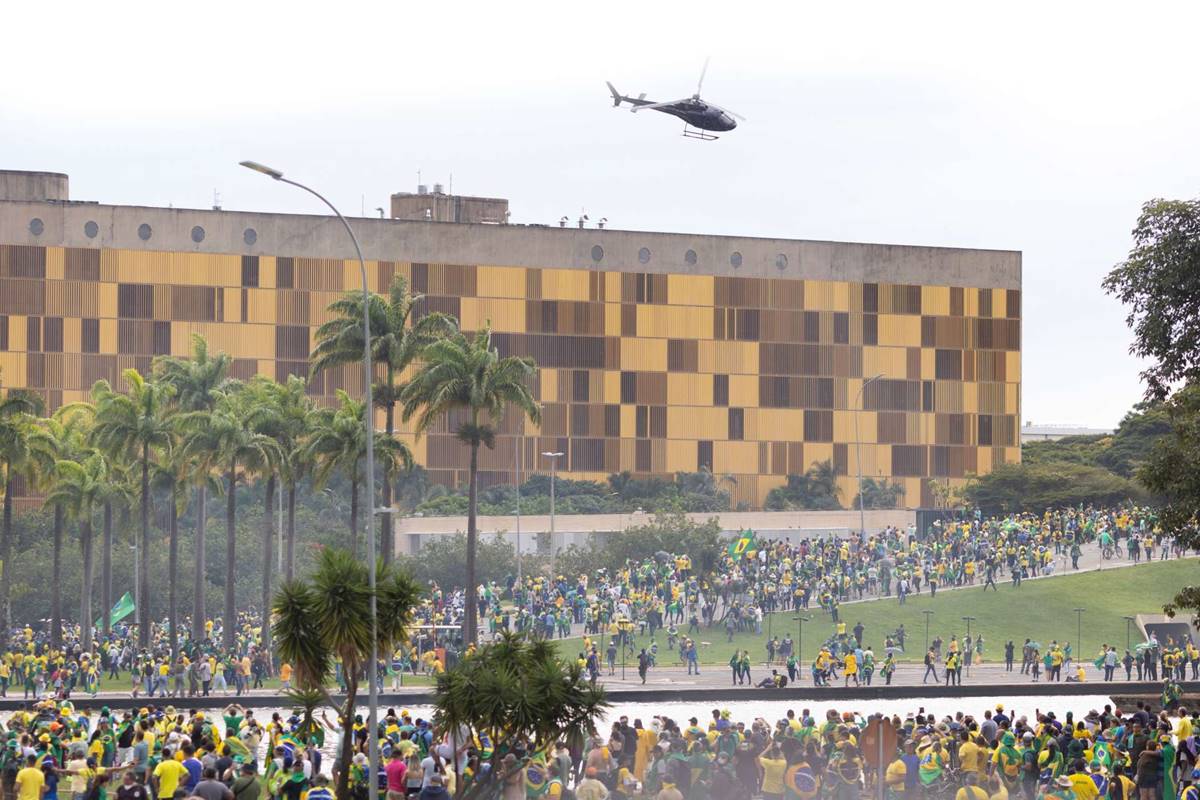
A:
[0,0,1200,426]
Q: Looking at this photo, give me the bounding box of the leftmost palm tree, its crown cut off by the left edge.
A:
[0,389,43,646]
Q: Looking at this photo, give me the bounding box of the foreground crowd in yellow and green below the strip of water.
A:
[7,698,1200,800]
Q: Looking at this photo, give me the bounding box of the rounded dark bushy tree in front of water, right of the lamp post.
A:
[433,632,610,798]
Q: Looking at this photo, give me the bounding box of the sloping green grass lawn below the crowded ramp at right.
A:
[559,559,1200,666]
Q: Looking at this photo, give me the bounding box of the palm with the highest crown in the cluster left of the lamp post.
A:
[154,335,233,642]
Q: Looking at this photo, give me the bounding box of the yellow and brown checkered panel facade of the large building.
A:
[0,245,1021,506]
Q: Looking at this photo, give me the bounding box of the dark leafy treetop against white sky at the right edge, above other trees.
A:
[1103,199,1200,399]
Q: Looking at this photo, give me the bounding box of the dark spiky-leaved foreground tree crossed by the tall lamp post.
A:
[272,547,420,798]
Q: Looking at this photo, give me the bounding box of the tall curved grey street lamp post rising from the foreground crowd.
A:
[241,161,379,800]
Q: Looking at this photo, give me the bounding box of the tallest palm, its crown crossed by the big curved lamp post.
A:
[312,276,457,564]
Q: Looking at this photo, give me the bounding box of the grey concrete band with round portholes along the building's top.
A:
[0,199,1021,289]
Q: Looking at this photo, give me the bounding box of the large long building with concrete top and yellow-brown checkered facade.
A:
[0,173,1021,507]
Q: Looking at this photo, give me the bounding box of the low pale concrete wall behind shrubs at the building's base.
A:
[394,509,917,554]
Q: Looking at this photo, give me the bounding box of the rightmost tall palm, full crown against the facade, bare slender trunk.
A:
[401,325,541,642]
